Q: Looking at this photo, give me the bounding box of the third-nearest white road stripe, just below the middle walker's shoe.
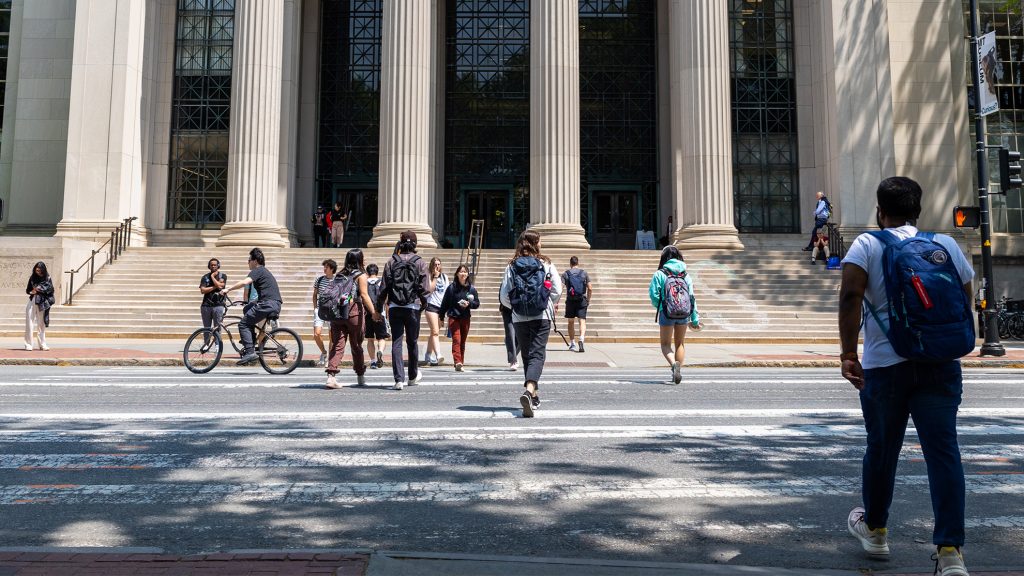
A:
[0,424,1024,444]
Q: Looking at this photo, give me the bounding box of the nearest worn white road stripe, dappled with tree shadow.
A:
[0,475,1024,505]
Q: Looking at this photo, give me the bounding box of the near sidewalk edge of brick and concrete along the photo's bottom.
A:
[0,547,1024,576]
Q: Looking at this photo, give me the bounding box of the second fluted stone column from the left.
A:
[369,0,437,243]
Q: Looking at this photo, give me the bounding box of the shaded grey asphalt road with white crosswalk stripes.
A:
[0,366,1024,570]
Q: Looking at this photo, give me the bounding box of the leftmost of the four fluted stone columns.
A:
[217,0,287,247]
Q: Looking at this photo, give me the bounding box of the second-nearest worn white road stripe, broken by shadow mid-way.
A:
[0,444,1024,471]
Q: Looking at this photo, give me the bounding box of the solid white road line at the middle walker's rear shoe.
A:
[0,407,1024,423]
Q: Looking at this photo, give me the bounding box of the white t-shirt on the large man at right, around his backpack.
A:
[843,224,974,369]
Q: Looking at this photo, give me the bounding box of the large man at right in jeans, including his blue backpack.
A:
[839,176,975,576]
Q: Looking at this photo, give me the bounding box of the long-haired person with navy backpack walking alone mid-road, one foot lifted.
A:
[499,230,562,418]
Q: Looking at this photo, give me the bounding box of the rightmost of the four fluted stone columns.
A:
[669,0,743,249]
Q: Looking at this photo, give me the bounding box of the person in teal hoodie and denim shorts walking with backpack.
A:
[647,245,702,384]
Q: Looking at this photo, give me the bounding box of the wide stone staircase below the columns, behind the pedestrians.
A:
[0,244,840,342]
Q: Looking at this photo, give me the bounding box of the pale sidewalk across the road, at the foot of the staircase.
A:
[0,336,1024,369]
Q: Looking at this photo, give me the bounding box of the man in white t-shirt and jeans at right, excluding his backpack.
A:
[839,176,974,576]
